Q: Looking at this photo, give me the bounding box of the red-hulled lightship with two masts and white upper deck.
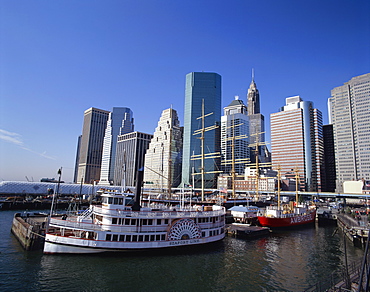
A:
[257,168,316,228]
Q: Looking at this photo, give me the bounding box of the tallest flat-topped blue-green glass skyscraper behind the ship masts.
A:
[181,72,221,188]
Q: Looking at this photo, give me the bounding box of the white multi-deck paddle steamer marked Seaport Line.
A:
[44,192,225,254]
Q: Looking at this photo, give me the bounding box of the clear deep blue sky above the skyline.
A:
[0,0,370,181]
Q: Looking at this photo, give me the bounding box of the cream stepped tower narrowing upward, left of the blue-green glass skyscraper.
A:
[144,108,182,190]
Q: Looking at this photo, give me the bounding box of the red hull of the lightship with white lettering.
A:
[258,210,316,228]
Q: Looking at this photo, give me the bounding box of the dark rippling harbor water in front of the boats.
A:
[0,211,363,291]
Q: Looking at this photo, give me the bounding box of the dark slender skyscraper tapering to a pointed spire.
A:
[247,74,267,163]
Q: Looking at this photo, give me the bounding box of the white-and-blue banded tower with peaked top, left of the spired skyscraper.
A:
[221,96,250,175]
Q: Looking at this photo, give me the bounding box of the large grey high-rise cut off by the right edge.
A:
[328,73,370,192]
